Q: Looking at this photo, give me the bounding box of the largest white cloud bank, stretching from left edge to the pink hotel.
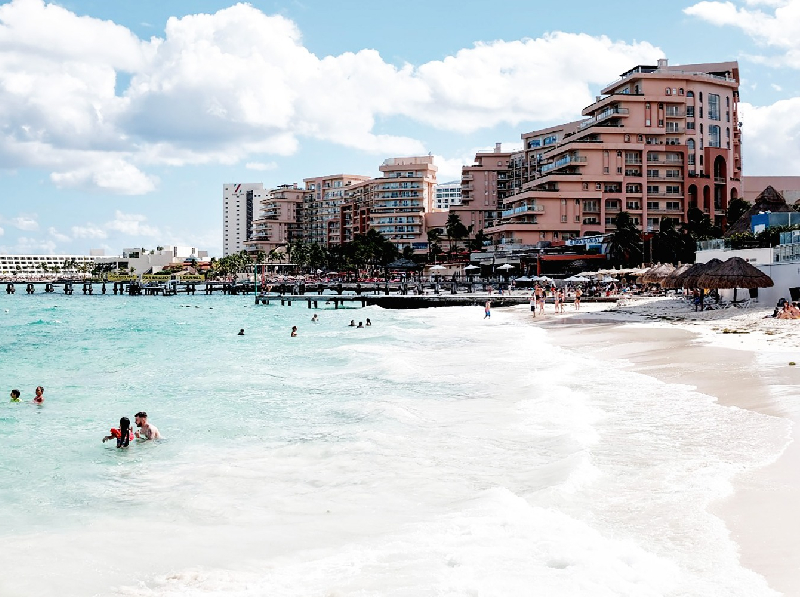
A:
[0,0,662,192]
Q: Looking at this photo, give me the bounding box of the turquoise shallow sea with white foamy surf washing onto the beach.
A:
[0,294,788,595]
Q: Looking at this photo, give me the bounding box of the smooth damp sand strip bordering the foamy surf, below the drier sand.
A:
[536,318,800,596]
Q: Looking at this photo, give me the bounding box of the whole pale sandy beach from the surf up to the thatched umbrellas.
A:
[512,302,800,596]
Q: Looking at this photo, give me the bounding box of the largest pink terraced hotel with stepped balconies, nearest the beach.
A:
[484,59,742,244]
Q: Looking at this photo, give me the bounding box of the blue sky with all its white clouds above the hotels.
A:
[0,0,800,256]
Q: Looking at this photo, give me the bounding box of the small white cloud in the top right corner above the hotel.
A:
[684,0,800,69]
